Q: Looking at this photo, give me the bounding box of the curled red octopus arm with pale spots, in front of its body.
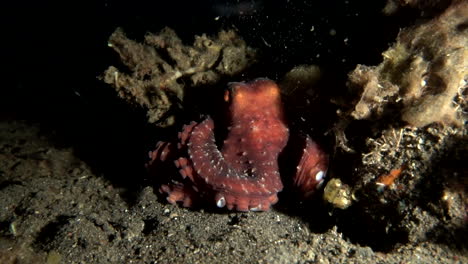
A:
[188,118,282,211]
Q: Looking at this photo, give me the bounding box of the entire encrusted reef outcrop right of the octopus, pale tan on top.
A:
[324,1,468,248]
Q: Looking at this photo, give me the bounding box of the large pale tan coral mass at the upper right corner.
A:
[349,2,468,127]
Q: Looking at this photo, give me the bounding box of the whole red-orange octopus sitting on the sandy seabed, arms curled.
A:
[147,79,328,211]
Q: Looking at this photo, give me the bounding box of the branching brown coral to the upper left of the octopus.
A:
[103,28,255,126]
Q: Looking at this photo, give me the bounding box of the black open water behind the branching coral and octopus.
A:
[0,0,414,187]
